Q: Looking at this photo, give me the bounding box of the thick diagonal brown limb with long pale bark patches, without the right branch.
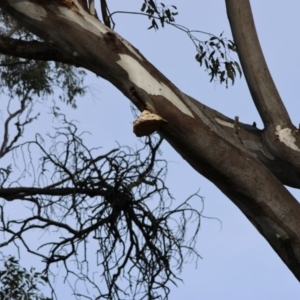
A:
[0,0,300,280]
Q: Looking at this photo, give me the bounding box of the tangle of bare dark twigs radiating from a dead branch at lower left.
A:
[0,115,201,299]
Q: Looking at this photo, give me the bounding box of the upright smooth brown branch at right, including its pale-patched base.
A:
[226,0,300,172]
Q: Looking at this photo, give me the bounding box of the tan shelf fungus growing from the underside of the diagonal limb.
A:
[133,110,168,137]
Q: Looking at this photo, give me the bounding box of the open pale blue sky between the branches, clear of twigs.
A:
[2,0,300,300]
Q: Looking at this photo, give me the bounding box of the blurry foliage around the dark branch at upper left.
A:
[0,11,86,108]
